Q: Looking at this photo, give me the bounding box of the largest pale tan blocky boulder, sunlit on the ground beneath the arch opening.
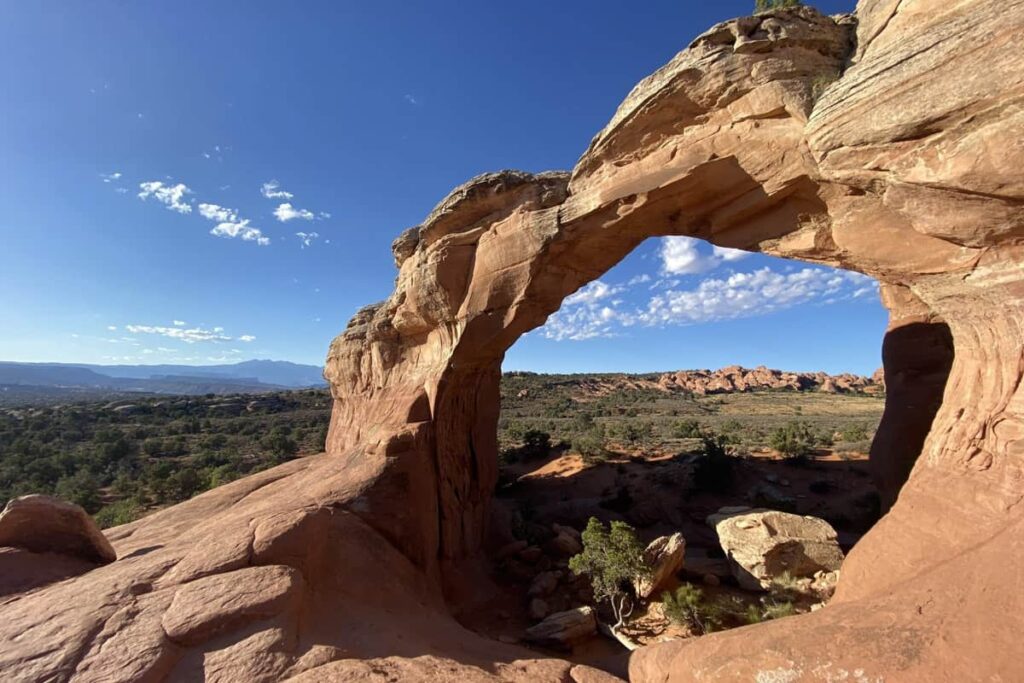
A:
[708,507,843,591]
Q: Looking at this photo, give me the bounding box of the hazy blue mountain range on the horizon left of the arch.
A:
[0,360,327,394]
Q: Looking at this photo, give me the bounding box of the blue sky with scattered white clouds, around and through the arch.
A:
[0,0,886,372]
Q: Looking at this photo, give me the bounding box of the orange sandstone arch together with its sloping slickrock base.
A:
[0,0,1024,682]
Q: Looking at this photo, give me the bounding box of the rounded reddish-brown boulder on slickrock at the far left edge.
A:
[0,495,118,564]
